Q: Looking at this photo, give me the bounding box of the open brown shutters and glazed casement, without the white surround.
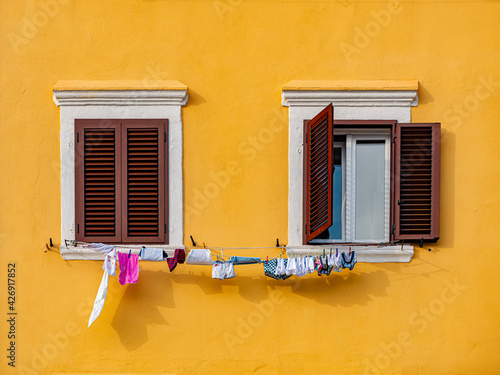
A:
[304,104,440,244]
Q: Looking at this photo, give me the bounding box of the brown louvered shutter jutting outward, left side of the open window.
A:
[304,104,333,243]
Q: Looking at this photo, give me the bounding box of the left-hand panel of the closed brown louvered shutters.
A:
[75,120,121,242]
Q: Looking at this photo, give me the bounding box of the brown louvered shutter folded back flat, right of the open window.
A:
[394,123,441,242]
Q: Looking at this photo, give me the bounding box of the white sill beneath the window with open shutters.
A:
[286,245,413,263]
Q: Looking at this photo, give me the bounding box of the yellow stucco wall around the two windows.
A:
[0,0,500,374]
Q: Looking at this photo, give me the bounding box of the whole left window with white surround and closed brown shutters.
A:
[53,81,188,260]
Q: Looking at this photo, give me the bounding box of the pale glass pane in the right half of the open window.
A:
[355,141,385,240]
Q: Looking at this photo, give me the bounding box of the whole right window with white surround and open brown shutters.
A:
[282,80,439,262]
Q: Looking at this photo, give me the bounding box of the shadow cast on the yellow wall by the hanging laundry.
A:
[111,265,389,351]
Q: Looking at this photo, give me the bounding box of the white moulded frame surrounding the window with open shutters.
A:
[281,81,418,263]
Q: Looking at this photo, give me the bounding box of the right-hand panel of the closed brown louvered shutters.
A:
[122,120,168,243]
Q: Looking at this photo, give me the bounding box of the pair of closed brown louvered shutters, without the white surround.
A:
[75,119,168,244]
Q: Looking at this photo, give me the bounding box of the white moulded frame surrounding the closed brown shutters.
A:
[53,81,188,260]
